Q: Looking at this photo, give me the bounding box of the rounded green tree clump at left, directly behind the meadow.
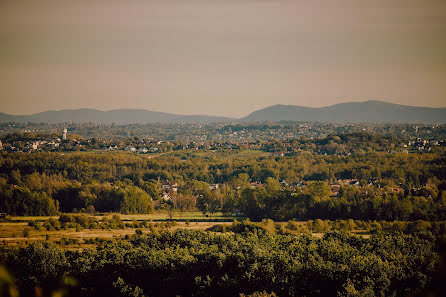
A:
[0,178,153,216]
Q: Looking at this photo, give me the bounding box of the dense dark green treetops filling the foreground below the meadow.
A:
[0,229,440,296]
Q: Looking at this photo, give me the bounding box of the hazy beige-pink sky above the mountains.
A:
[0,0,446,117]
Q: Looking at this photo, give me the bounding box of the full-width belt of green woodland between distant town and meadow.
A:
[0,151,446,220]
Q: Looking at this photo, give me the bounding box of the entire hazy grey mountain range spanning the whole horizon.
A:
[0,101,446,124]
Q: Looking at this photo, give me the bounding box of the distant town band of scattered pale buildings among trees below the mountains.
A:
[0,124,446,157]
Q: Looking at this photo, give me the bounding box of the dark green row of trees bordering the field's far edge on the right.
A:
[236,179,446,221]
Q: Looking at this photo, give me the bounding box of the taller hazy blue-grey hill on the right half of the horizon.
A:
[241,101,446,123]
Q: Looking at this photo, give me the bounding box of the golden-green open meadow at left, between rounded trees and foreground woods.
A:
[0,211,239,248]
